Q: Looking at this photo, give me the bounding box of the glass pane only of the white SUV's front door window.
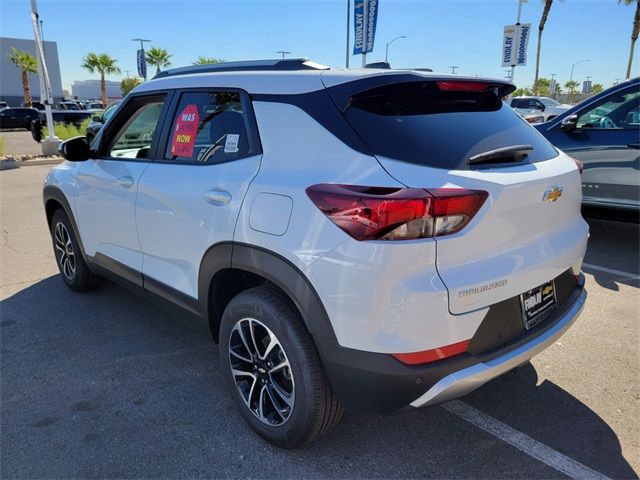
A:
[108,97,164,158]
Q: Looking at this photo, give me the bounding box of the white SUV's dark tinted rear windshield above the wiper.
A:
[345,81,557,170]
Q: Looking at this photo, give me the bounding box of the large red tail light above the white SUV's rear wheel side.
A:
[307,184,488,240]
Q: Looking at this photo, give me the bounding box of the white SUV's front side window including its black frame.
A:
[105,95,164,158]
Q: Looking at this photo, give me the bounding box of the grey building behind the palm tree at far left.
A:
[0,37,63,107]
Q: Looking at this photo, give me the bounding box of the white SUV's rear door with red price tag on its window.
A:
[136,89,261,298]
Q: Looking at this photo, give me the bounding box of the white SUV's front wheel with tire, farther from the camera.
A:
[51,208,103,292]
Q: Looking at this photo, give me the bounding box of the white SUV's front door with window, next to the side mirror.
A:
[76,94,166,284]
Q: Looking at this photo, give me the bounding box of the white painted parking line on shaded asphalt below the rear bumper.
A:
[442,400,609,480]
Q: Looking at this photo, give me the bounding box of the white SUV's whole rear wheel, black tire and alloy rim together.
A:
[220,287,342,448]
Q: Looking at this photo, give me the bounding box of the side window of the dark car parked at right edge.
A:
[577,87,640,130]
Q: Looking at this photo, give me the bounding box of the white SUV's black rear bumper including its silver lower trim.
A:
[315,277,587,414]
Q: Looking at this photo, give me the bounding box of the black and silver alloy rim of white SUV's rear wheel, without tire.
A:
[229,318,295,426]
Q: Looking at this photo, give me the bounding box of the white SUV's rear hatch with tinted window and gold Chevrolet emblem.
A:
[328,74,588,314]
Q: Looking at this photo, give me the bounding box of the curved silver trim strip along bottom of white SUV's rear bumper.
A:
[410,290,587,407]
